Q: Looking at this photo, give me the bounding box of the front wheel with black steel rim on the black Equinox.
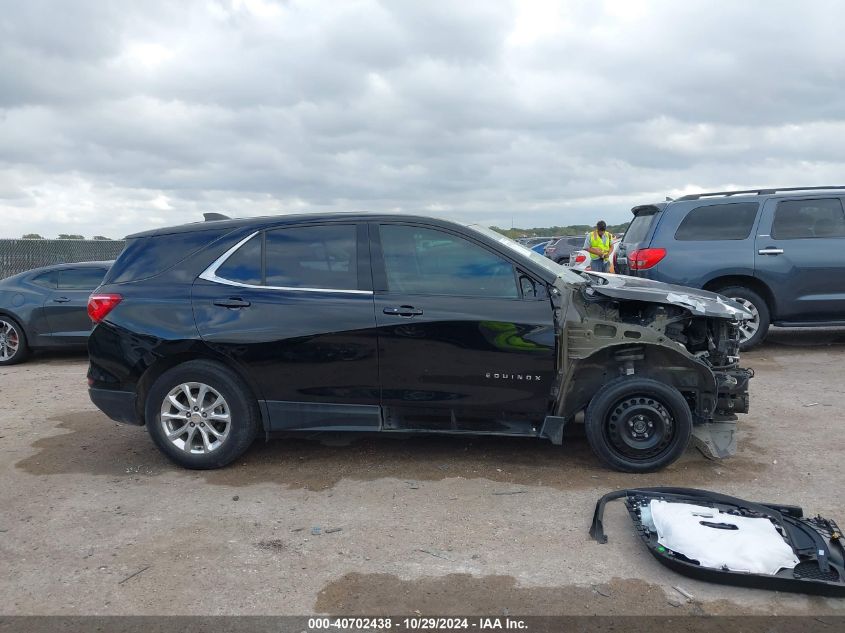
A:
[584,377,692,473]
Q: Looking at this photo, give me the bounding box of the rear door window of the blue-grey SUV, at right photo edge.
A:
[772,198,845,240]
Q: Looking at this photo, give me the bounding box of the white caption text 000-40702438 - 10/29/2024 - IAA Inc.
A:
[308,616,528,631]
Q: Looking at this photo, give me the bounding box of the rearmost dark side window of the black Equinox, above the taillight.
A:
[103,229,226,284]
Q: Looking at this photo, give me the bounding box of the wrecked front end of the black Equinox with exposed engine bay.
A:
[555,275,754,459]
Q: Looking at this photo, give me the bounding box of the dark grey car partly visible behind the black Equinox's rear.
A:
[0,262,112,365]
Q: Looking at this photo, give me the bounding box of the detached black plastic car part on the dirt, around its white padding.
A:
[590,488,845,597]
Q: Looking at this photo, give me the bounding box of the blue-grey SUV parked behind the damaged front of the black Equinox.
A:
[616,187,845,349]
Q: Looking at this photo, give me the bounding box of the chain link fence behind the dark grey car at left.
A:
[0,239,126,279]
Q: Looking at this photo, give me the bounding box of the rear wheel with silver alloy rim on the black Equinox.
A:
[144,360,261,470]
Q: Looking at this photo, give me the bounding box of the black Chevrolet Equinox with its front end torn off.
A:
[88,214,751,472]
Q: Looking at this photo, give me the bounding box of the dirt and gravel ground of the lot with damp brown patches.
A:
[0,330,845,615]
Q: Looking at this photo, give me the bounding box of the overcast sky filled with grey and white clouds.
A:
[0,0,845,237]
